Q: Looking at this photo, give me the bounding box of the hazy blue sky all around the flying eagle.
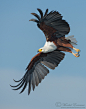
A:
[0,0,86,109]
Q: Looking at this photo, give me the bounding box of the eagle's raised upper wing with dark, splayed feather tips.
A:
[30,9,70,41]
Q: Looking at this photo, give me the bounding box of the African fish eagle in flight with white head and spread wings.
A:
[10,9,80,95]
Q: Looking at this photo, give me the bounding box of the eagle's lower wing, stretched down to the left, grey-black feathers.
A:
[11,50,65,95]
